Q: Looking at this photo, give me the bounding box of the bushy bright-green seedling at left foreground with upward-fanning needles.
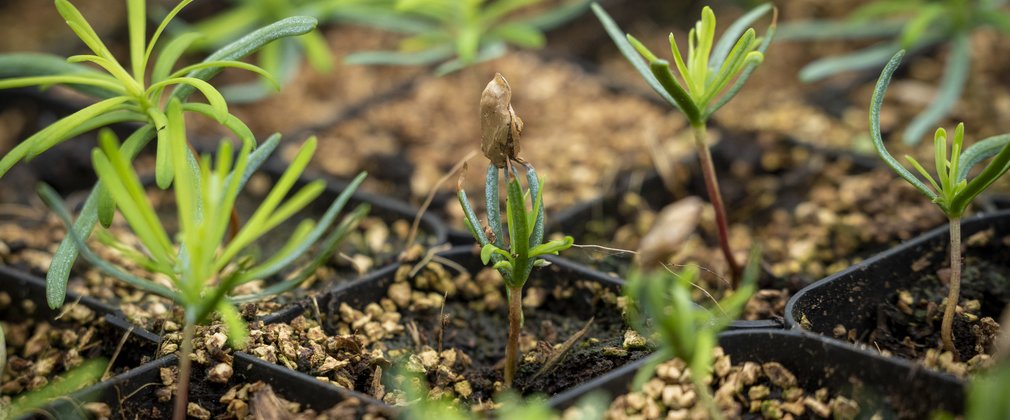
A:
[39,99,369,419]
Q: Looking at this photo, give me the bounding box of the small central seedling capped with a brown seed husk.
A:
[457,74,574,388]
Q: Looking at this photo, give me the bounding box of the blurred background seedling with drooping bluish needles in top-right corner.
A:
[780,0,1010,144]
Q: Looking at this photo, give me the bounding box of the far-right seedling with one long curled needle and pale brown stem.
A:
[870,50,1010,357]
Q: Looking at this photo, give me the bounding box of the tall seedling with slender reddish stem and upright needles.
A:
[593,4,777,287]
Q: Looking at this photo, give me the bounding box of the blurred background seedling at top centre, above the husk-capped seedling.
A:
[345,0,589,75]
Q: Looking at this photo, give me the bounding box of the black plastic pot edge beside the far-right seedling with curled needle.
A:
[785,210,1010,355]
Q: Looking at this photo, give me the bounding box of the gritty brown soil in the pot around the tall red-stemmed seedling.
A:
[557,135,944,319]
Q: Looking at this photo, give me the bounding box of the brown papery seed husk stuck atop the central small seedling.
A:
[481,73,523,168]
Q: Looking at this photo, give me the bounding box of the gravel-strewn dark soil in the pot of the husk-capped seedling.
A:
[249,263,648,410]
